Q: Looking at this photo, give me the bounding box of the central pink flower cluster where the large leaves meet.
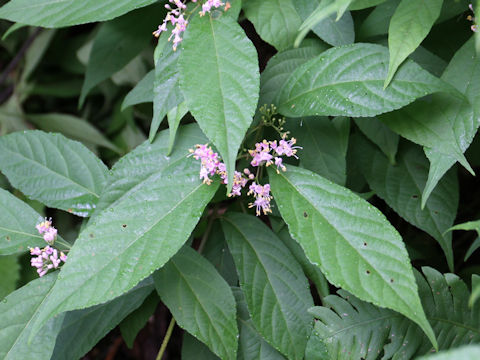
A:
[190,136,301,216]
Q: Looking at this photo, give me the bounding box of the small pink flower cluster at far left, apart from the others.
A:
[30,219,67,277]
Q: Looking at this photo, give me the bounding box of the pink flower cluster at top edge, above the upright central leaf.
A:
[153,0,229,51]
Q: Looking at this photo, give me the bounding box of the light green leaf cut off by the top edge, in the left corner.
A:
[0,0,155,31]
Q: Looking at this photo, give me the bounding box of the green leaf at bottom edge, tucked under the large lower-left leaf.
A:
[154,247,238,360]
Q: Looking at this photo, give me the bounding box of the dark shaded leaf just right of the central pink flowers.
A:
[285,116,348,185]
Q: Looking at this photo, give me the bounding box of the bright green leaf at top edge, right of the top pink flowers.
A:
[243,0,301,51]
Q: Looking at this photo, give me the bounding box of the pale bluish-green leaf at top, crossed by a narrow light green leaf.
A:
[294,0,355,46]
